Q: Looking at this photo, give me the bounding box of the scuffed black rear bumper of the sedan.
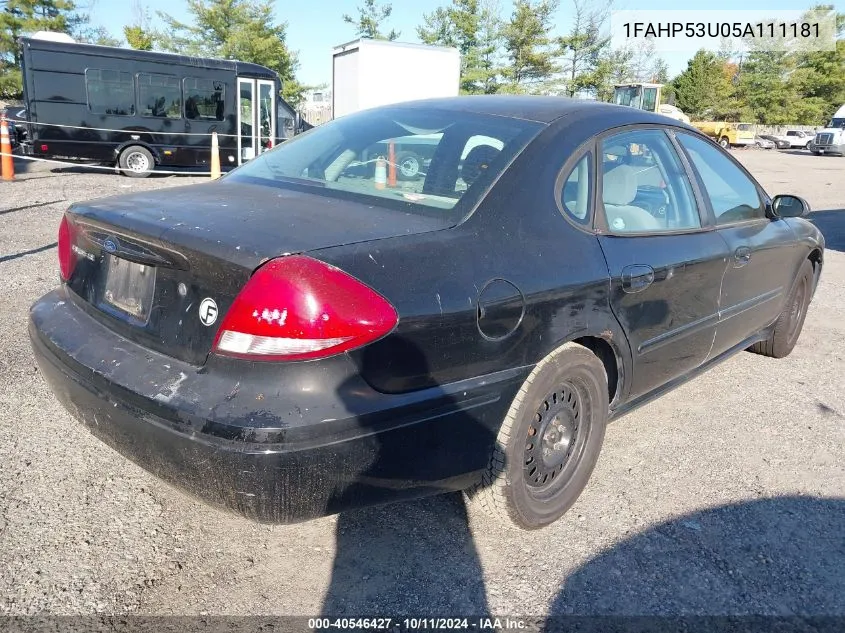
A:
[29,289,530,523]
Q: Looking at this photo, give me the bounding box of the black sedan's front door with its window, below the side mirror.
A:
[677,133,798,356]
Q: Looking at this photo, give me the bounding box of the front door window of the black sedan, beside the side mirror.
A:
[678,134,766,224]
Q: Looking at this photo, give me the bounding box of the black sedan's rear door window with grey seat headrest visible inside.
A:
[601,129,701,234]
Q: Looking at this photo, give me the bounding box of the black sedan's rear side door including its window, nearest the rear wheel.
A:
[597,127,727,399]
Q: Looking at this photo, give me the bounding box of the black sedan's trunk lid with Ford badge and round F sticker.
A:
[68,180,448,365]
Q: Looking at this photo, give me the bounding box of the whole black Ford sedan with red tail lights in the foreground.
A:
[29,96,824,528]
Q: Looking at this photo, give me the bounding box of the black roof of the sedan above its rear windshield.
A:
[388,95,688,127]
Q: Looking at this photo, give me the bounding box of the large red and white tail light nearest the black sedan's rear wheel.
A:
[214,255,398,360]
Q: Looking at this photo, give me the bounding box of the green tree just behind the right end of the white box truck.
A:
[417,0,501,94]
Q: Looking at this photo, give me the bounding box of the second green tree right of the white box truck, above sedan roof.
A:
[502,0,558,92]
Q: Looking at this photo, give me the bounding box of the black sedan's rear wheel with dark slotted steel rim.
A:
[466,343,609,530]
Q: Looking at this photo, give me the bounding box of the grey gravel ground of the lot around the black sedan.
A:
[0,151,845,616]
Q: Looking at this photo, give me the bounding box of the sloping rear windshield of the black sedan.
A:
[226,107,543,222]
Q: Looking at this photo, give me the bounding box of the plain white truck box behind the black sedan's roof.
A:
[332,39,461,119]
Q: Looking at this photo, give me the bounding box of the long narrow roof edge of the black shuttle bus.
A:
[19,37,278,78]
